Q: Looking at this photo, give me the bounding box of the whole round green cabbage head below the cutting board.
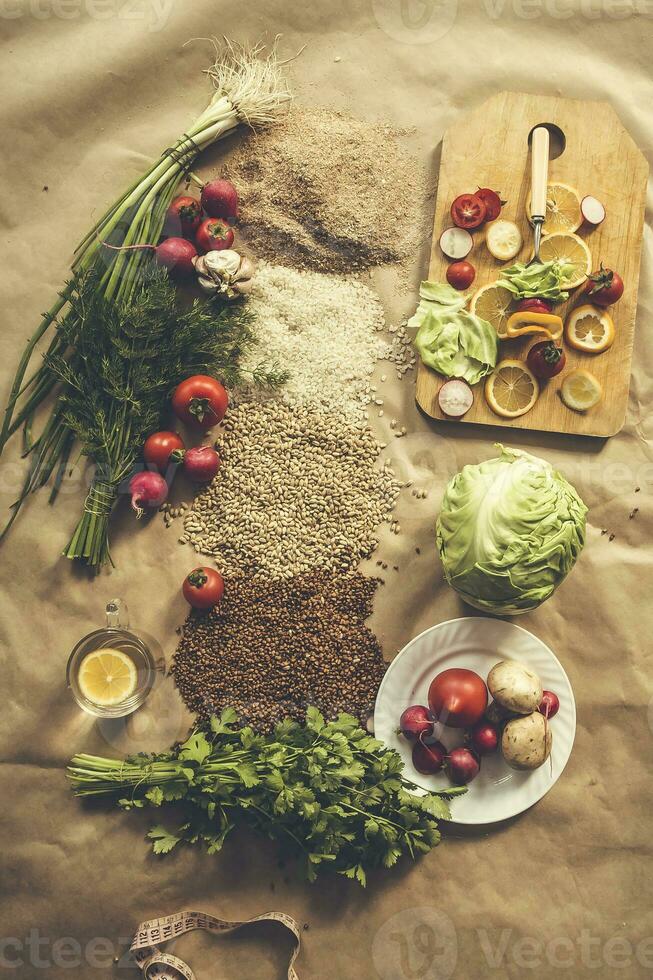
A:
[436,445,587,616]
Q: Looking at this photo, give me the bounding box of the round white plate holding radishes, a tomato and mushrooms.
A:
[374,617,576,825]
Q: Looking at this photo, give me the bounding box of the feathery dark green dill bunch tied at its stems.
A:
[46,269,285,568]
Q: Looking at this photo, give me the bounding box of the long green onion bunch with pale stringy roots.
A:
[0,41,290,563]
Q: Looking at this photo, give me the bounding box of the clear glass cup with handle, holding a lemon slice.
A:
[66,599,156,718]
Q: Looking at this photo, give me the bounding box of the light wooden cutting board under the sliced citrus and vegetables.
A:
[416,92,648,437]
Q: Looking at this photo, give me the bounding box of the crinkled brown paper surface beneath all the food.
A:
[0,0,653,980]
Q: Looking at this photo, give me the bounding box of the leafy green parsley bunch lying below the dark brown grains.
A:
[68,708,465,886]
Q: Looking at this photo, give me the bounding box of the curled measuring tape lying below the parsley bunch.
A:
[130,912,301,980]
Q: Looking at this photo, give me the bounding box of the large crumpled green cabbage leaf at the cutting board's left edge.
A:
[408,282,499,385]
